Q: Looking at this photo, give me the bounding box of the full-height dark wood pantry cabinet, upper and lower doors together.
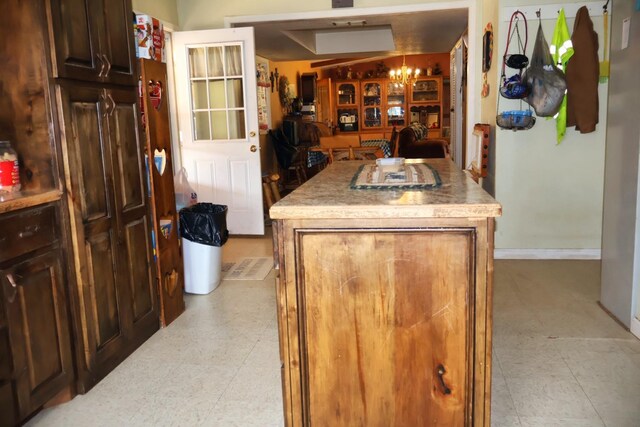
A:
[49,0,159,392]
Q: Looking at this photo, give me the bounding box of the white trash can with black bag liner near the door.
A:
[180,203,229,294]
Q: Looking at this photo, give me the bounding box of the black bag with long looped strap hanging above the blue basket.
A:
[500,10,529,99]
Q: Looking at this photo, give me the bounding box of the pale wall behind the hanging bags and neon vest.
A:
[496,0,607,252]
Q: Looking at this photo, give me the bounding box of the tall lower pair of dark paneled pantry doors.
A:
[56,81,159,388]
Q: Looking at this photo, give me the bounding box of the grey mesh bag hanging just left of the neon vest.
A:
[523,25,567,117]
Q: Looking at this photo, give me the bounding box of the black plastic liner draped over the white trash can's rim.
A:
[180,203,229,246]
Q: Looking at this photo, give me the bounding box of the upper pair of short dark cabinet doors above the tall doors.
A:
[49,0,137,85]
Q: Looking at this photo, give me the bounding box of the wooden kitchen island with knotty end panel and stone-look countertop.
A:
[270,159,501,427]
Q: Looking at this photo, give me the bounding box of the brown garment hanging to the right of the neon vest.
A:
[566,6,600,133]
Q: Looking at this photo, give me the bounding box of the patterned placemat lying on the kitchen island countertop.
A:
[351,163,442,190]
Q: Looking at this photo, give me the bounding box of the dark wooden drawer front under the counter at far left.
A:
[0,206,56,262]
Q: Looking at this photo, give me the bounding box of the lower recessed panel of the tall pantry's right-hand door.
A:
[126,218,154,322]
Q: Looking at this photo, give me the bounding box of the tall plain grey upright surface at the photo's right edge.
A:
[601,0,640,326]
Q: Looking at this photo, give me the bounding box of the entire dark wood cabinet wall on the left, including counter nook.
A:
[0,0,159,426]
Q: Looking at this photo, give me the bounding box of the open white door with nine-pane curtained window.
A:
[173,27,264,234]
